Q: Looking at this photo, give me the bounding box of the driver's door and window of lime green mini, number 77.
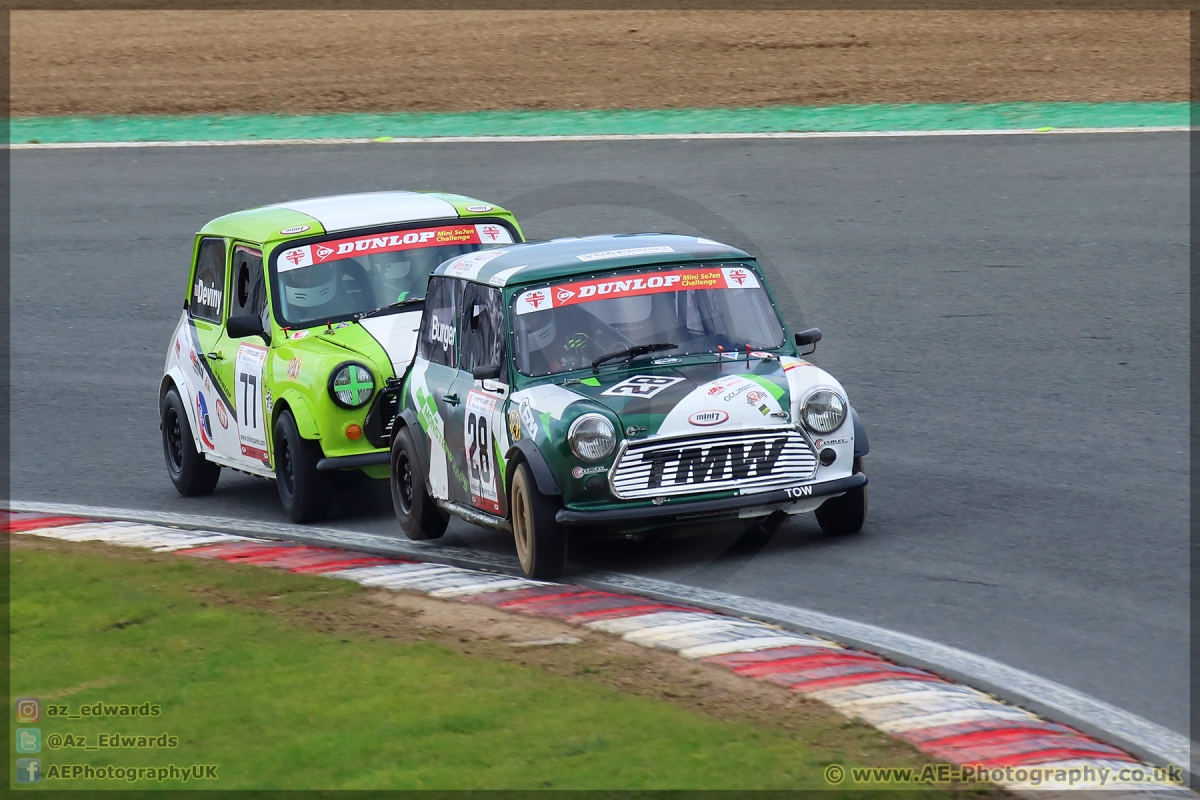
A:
[212,243,271,468]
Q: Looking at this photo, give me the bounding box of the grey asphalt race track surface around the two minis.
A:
[11,133,1189,734]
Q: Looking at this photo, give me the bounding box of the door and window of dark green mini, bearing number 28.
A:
[451,283,509,516]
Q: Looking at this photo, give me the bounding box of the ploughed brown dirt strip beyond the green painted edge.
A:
[11,11,1188,115]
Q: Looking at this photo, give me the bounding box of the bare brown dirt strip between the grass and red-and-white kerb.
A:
[10,535,1007,796]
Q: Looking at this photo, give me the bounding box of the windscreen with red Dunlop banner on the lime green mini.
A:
[272,221,512,327]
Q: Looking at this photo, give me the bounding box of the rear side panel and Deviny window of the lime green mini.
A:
[176,236,229,456]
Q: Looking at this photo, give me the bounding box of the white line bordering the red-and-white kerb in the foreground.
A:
[5,500,1200,772]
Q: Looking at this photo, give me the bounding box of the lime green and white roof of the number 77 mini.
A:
[200,192,510,242]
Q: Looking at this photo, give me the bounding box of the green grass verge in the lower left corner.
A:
[11,537,1003,794]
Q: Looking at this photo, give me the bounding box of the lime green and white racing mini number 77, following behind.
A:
[158,192,522,522]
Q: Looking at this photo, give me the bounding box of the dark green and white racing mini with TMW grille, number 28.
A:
[389,234,868,578]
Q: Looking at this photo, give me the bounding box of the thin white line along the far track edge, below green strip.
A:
[7,125,1190,150]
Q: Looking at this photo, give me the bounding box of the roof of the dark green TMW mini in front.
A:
[433,234,754,287]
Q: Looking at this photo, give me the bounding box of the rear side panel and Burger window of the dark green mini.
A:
[409,276,470,503]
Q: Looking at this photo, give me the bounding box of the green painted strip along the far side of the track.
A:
[10,103,1188,144]
